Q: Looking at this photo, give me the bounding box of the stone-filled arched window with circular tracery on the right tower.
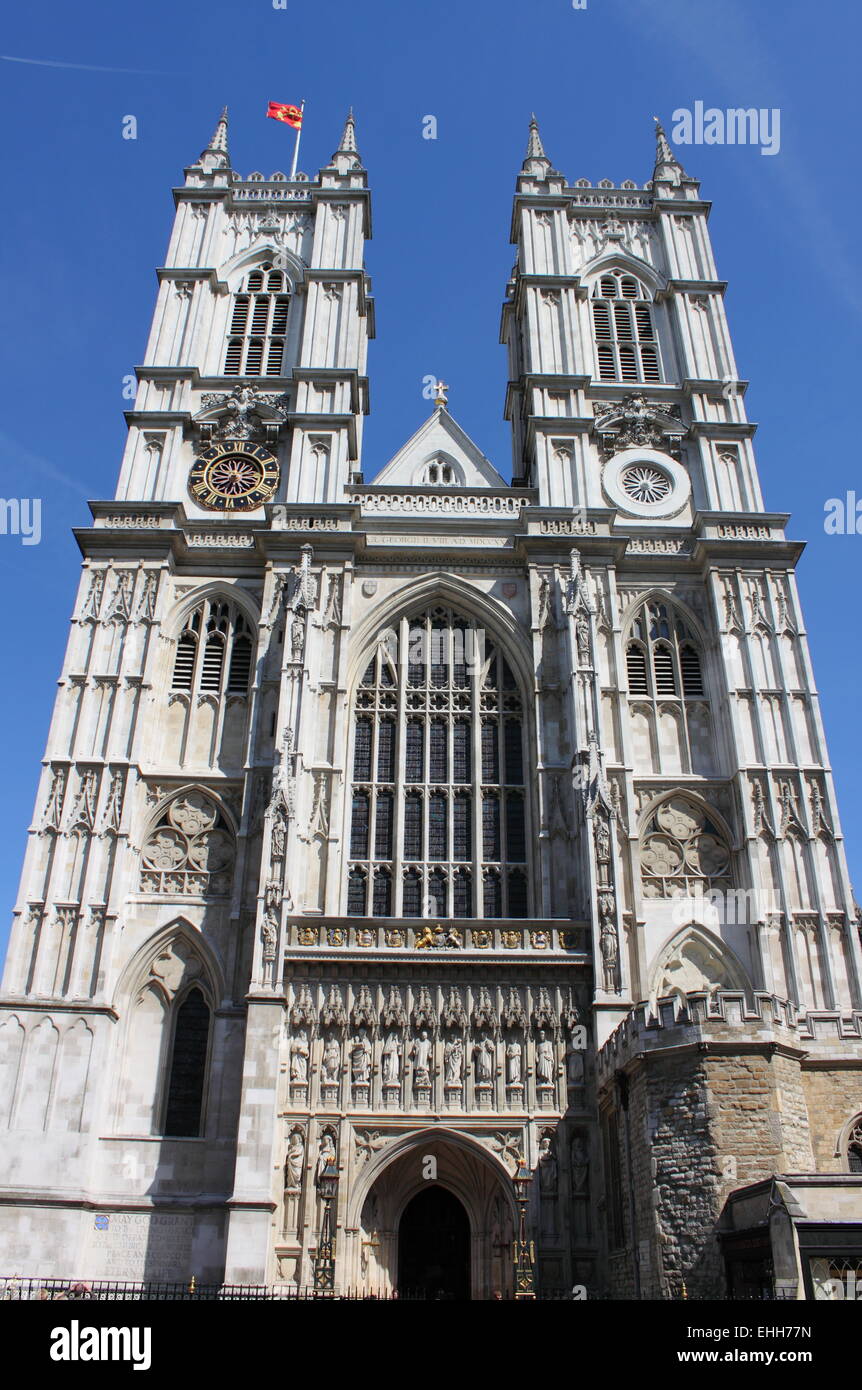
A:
[641,796,733,898]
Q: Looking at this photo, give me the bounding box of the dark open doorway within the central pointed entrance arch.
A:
[398,1183,470,1301]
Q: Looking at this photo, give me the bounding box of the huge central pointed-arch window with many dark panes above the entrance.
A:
[348,607,528,917]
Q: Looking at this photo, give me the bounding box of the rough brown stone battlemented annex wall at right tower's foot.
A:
[598,995,862,1298]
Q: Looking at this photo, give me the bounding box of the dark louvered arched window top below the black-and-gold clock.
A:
[171,599,253,696]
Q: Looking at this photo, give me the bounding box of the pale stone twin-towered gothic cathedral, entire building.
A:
[0,115,862,1300]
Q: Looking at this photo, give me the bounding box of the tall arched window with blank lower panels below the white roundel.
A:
[626,599,715,774]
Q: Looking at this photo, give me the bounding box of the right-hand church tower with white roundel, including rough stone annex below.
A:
[502,121,862,1298]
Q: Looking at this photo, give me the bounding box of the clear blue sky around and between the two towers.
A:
[0,0,862,956]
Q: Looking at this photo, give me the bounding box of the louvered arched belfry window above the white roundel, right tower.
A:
[592,270,662,381]
